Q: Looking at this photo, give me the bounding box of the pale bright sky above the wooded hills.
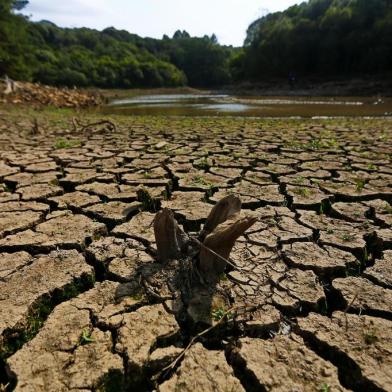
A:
[24,0,301,46]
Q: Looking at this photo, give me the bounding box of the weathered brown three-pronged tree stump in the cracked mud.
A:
[148,195,257,323]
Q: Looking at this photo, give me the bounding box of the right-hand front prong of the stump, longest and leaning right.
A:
[199,214,257,282]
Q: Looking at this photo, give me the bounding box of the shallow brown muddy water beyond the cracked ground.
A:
[103,94,392,117]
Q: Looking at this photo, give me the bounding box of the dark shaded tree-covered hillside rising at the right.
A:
[234,0,392,80]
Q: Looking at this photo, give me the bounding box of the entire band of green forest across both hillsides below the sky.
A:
[0,0,392,88]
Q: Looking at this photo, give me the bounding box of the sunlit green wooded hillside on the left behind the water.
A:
[0,0,232,88]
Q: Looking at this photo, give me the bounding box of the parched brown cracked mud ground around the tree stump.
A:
[0,108,392,392]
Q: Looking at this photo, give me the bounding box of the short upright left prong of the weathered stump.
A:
[154,208,186,263]
